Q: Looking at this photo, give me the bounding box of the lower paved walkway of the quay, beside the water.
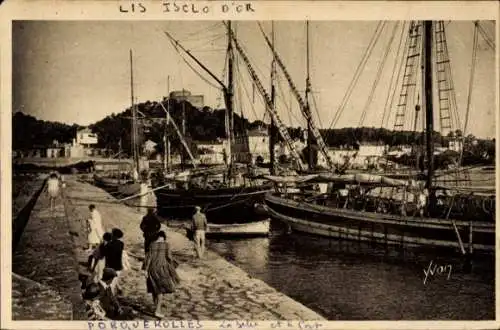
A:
[65,178,323,320]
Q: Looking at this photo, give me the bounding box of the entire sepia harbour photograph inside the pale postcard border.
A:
[2,1,498,329]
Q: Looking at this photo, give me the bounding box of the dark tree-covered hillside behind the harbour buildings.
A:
[12,99,495,164]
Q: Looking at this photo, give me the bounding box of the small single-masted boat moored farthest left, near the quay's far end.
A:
[94,50,147,198]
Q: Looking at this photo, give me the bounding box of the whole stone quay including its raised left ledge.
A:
[13,176,324,321]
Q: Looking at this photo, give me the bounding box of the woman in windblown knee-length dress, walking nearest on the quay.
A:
[144,230,180,318]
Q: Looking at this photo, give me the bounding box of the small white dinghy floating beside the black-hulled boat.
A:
[186,219,270,240]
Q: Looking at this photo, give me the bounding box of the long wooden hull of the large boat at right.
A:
[265,193,495,252]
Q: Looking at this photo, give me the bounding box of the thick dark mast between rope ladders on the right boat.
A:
[423,21,434,192]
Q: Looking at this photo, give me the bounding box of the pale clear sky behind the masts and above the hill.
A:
[12,21,496,137]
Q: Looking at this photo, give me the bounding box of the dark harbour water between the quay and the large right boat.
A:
[208,222,495,320]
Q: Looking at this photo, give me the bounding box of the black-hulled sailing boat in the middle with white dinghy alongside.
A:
[155,22,272,236]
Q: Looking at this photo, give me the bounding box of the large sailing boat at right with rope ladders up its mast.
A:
[265,21,495,255]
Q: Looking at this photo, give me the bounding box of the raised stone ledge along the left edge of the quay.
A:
[12,178,86,320]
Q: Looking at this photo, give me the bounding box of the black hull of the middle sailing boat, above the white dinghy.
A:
[155,185,271,224]
